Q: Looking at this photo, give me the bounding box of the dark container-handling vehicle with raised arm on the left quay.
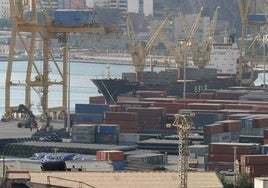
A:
[12,104,38,128]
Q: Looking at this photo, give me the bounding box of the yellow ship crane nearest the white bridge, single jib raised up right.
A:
[191,6,220,68]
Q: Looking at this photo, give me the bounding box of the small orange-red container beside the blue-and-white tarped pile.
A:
[96,150,124,161]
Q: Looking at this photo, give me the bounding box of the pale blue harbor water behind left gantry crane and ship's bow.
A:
[0,60,142,115]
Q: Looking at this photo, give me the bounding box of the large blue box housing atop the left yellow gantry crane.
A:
[54,10,99,26]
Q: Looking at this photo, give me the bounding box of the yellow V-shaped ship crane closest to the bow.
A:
[127,13,172,81]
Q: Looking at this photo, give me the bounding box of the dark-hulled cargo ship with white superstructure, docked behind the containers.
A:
[91,41,258,104]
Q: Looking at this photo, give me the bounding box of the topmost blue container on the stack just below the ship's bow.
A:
[75,104,109,114]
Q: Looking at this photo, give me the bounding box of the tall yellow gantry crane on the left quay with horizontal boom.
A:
[4,0,111,121]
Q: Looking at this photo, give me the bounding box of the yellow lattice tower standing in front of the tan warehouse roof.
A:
[166,114,193,188]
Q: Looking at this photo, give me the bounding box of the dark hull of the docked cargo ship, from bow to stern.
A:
[91,77,238,104]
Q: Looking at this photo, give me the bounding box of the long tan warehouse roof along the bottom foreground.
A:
[29,171,223,188]
